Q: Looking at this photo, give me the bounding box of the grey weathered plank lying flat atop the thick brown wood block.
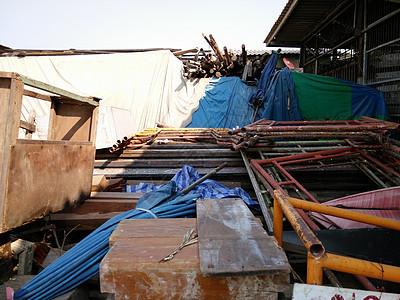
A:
[197,198,290,276]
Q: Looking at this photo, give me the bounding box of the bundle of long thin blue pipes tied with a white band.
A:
[14,181,201,300]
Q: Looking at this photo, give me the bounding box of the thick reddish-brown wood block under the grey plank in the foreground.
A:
[100,219,289,299]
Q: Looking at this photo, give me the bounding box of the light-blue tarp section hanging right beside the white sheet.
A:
[187,77,257,128]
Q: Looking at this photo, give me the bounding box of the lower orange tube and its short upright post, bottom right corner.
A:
[307,253,400,285]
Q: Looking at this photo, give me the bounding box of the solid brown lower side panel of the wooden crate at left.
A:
[2,140,94,230]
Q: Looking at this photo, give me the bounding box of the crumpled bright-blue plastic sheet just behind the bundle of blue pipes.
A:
[126,165,260,210]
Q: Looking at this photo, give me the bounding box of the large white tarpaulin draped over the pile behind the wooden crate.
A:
[0,50,208,148]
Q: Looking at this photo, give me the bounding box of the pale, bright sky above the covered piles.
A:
[0,0,287,50]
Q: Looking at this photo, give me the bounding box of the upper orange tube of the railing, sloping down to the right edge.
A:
[288,197,400,230]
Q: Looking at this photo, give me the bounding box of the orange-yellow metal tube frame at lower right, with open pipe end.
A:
[273,190,400,285]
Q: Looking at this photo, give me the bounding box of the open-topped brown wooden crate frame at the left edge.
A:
[0,72,99,232]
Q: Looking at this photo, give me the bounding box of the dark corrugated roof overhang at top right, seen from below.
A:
[264,0,349,47]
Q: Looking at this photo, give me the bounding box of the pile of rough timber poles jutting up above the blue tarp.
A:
[184,33,267,80]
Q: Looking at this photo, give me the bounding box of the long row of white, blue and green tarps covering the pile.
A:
[0,50,388,144]
